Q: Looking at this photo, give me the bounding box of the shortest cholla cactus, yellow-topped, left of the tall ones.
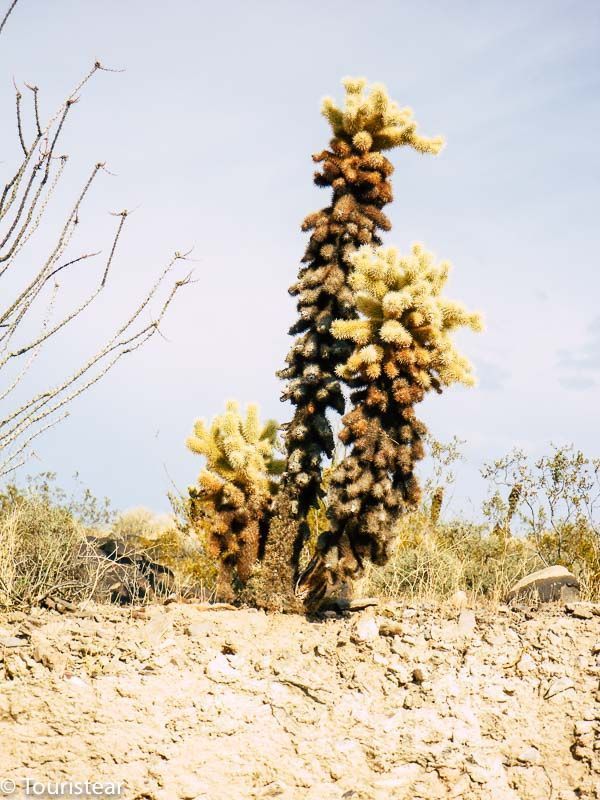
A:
[186,401,283,600]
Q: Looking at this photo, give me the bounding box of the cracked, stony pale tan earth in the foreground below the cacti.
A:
[0,604,600,800]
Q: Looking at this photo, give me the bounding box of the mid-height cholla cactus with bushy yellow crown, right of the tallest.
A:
[300,245,482,607]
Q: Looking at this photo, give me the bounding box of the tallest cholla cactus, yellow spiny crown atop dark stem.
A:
[278,78,443,515]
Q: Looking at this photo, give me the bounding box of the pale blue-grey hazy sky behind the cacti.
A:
[0,0,600,513]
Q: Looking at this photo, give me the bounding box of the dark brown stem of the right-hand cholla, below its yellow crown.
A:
[302,375,427,609]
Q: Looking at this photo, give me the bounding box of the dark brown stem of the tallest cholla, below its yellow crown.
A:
[259,145,394,607]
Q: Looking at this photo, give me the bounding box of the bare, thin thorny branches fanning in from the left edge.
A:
[0,1,189,477]
